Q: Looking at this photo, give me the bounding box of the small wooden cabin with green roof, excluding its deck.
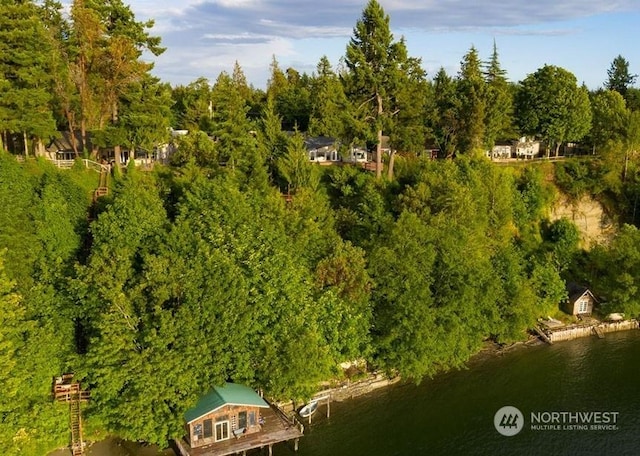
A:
[185,383,269,448]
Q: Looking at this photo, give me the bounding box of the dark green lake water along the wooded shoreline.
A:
[70,331,640,456]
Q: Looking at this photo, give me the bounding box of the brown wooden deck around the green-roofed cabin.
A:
[175,405,304,456]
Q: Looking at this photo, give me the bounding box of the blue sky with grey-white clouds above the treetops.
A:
[125,0,640,89]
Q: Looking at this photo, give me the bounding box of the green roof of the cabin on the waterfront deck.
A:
[184,383,269,423]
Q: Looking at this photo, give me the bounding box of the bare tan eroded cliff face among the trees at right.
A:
[550,195,614,250]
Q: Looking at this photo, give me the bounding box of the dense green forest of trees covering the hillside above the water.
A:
[0,0,640,455]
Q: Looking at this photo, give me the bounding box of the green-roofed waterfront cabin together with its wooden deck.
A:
[176,383,304,456]
